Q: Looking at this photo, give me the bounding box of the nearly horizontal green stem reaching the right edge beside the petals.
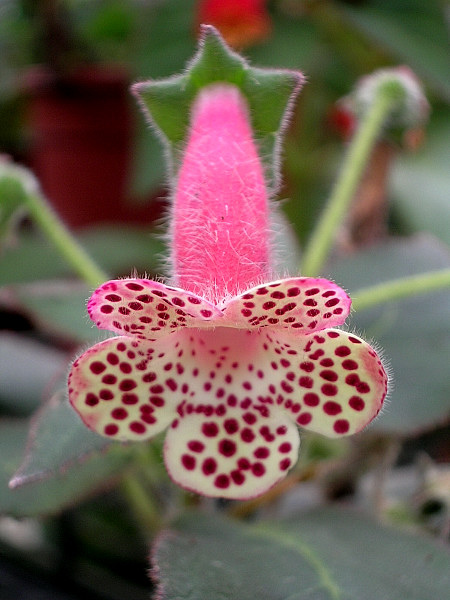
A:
[352,269,450,310]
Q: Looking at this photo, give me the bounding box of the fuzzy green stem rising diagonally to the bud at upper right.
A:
[302,86,399,276]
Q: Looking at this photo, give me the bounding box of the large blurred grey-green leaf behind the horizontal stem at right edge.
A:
[326,236,450,433]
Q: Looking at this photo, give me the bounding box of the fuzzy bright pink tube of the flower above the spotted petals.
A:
[170,84,270,301]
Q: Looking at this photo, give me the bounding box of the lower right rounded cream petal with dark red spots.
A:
[267,329,387,437]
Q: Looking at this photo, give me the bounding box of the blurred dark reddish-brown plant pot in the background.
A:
[26,66,160,227]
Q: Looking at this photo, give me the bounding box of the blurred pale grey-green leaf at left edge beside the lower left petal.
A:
[0,332,68,415]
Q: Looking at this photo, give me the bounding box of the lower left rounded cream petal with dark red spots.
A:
[69,337,179,441]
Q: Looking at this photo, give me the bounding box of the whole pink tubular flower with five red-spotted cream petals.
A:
[69,83,387,499]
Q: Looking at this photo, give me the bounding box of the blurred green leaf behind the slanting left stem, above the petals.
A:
[0,226,162,285]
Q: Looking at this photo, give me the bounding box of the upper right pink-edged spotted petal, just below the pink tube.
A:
[223,277,351,334]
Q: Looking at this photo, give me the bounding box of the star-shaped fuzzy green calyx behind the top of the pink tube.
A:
[135,25,302,182]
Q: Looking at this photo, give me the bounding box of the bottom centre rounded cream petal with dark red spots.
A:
[164,399,300,500]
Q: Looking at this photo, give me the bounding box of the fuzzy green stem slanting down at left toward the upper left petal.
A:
[24,190,108,287]
